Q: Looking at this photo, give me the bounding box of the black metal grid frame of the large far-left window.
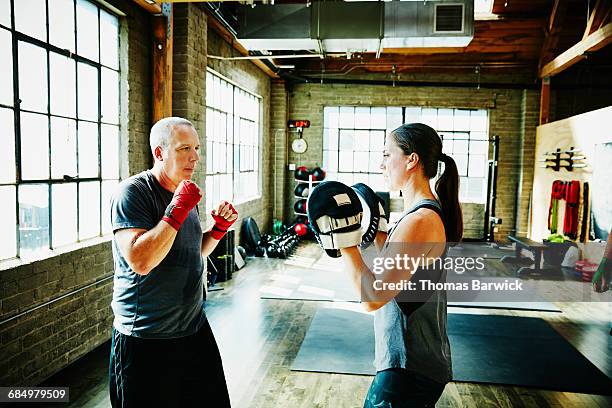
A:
[0,0,124,263]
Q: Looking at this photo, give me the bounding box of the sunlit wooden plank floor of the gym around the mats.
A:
[35,245,612,408]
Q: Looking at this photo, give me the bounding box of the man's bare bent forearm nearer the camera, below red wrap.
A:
[129,221,177,275]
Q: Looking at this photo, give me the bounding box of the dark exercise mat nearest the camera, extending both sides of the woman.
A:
[291,308,612,395]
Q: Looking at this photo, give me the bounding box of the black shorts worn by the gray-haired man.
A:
[109,321,230,408]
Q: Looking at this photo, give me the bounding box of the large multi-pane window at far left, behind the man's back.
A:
[0,0,119,259]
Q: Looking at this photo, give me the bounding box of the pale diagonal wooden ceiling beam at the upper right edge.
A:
[539,23,612,78]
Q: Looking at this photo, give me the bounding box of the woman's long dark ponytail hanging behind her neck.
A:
[436,153,463,242]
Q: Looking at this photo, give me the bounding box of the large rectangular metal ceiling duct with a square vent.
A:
[237,0,474,53]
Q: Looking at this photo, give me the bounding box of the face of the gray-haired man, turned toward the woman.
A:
[162,125,200,184]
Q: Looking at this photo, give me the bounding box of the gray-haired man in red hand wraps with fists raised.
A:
[109,117,238,407]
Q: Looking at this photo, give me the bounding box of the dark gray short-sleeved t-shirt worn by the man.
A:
[111,170,206,338]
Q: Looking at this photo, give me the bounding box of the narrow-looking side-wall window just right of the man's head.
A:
[206,70,261,212]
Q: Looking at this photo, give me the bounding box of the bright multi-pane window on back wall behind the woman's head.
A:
[323,106,489,203]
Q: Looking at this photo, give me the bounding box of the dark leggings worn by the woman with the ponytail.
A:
[363,368,446,408]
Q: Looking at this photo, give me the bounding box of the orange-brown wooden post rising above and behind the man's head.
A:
[152,3,173,123]
